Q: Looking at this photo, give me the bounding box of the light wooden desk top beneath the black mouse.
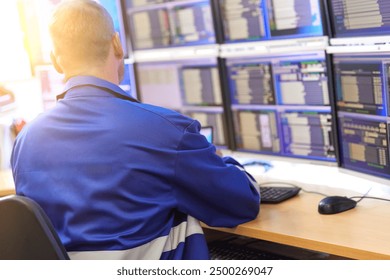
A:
[205,192,390,260]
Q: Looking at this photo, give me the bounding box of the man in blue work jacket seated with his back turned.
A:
[11,0,260,259]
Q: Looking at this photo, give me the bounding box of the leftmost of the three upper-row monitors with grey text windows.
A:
[125,0,216,50]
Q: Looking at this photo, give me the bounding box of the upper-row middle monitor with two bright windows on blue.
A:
[219,0,326,42]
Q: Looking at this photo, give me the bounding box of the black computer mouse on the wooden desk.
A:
[318,196,357,214]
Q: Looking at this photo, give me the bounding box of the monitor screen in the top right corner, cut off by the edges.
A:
[328,0,390,38]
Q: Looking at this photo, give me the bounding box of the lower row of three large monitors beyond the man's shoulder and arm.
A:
[135,51,390,182]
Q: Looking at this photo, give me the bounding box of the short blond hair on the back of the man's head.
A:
[49,0,115,69]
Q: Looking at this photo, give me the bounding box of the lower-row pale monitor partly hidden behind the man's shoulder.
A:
[136,57,228,146]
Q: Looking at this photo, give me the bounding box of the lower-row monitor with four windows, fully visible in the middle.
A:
[226,51,336,163]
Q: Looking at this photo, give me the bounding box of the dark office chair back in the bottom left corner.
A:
[0,195,69,260]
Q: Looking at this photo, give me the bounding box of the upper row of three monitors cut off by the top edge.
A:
[119,0,390,50]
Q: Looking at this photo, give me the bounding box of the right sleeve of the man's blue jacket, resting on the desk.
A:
[173,121,260,227]
